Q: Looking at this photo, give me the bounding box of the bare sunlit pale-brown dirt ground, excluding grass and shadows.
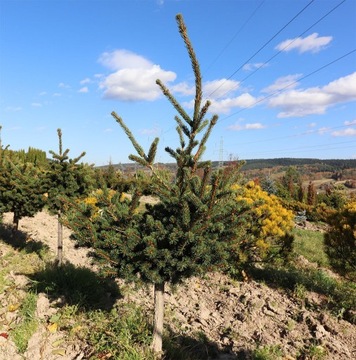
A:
[0,212,356,360]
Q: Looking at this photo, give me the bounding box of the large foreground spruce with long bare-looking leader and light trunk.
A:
[67,15,243,353]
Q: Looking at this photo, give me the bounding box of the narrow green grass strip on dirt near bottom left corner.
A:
[11,292,38,353]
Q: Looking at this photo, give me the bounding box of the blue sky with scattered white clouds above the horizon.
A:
[0,0,356,165]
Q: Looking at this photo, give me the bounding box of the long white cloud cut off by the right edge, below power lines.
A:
[268,72,356,118]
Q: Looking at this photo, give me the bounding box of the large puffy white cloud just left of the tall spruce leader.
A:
[99,50,176,101]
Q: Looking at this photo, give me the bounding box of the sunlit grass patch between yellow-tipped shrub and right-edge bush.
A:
[293,229,329,267]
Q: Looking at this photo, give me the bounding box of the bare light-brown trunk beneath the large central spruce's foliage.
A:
[152,283,164,356]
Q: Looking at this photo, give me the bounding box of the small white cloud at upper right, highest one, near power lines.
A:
[276,33,333,53]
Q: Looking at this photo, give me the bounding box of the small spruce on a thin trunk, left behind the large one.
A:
[47,129,93,265]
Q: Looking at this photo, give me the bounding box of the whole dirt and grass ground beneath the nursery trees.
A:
[0,212,356,360]
